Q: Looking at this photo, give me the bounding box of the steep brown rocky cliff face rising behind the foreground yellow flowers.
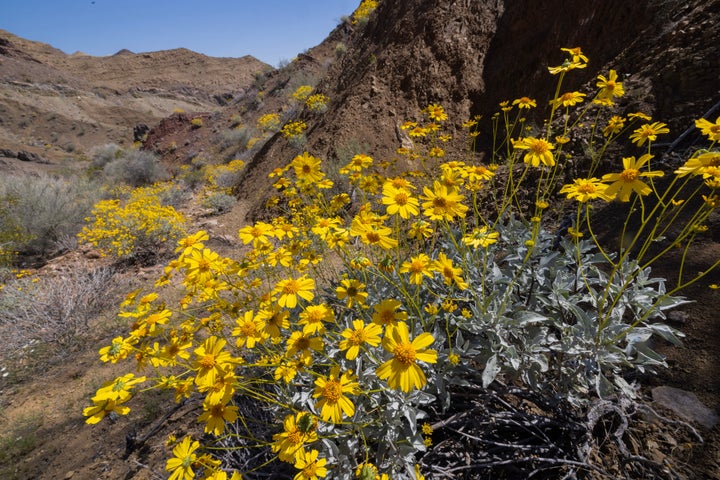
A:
[229,0,720,217]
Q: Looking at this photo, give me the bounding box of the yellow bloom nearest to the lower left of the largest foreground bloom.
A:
[313,367,360,423]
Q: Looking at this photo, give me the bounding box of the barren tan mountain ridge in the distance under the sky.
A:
[0,30,272,167]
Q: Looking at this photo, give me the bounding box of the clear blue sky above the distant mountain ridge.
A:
[0,0,360,66]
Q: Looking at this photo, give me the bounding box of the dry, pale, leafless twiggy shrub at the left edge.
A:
[0,267,117,365]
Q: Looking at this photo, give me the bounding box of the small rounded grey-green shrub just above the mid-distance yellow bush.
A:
[103,149,169,187]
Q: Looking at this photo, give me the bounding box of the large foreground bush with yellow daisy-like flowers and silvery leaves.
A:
[84,48,720,479]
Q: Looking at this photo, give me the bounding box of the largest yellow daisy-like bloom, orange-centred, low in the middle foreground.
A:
[375,322,437,392]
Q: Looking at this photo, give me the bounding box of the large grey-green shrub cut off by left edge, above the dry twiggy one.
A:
[0,175,101,256]
